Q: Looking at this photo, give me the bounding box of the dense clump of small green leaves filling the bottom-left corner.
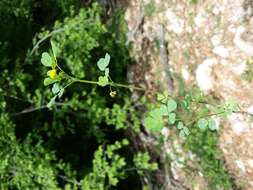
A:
[0,114,60,189]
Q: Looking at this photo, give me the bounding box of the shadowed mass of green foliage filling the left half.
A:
[0,0,152,189]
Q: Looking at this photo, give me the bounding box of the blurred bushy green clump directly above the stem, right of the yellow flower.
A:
[49,4,106,78]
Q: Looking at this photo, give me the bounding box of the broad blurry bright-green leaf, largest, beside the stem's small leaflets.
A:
[144,108,164,132]
